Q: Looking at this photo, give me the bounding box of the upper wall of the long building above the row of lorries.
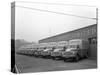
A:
[39,24,97,43]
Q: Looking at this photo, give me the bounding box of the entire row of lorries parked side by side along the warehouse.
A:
[17,39,89,61]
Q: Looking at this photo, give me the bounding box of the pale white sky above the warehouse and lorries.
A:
[15,2,96,42]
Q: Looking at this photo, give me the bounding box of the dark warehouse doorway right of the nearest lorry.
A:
[89,37,97,60]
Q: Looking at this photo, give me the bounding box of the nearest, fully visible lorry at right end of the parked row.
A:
[62,39,89,61]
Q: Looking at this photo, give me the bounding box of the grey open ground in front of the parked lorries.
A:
[15,54,97,73]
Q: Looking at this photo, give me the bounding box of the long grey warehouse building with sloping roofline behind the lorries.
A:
[39,24,97,59]
